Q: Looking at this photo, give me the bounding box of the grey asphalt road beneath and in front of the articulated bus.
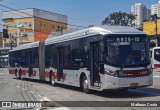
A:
[0,69,160,110]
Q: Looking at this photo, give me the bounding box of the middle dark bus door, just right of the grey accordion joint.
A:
[57,47,63,81]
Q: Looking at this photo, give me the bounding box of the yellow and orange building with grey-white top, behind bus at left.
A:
[2,8,68,47]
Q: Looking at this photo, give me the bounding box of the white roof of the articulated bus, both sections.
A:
[9,26,145,52]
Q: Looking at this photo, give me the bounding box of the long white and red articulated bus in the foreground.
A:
[9,26,153,93]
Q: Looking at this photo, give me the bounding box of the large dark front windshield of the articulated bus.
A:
[105,35,150,67]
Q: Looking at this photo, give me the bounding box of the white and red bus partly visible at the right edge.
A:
[151,47,160,69]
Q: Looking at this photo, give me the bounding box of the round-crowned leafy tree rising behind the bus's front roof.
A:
[101,11,135,26]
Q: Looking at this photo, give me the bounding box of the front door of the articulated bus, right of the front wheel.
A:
[90,42,100,86]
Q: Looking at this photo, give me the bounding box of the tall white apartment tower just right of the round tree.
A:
[131,3,151,29]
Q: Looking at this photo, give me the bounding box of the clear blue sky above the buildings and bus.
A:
[0,0,158,28]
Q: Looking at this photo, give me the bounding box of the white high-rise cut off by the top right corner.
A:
[151,0,160,17]
